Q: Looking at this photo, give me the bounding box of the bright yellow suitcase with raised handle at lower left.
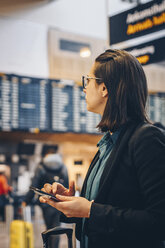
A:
[10,207,34,248]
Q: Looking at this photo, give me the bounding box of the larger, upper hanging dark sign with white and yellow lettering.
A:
[109,0,165,45]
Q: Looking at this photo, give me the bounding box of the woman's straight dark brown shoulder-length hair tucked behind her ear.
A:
[94,49,148,132]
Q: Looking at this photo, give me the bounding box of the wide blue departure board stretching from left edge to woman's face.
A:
[0,74,100,133]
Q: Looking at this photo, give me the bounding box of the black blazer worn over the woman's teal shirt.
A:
[76,122,165,248]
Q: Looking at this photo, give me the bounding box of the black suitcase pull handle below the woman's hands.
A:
[41,227,73,248]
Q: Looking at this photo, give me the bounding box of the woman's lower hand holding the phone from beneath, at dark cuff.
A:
[40,194,93,218]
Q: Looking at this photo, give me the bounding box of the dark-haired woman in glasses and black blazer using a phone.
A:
[40,50,165,248]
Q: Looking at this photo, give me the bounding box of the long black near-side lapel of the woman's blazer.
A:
[96,123,141,202]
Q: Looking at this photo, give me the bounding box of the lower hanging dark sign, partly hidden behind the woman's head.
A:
[125,37,165,65]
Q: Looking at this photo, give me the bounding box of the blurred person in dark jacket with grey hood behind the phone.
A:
[22,146,68,248]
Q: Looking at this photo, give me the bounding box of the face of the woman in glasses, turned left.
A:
[84,63,108,115]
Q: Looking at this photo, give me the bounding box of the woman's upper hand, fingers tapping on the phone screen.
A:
[41,181,75,196]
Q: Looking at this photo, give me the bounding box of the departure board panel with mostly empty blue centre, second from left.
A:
[19,77,50,131]
